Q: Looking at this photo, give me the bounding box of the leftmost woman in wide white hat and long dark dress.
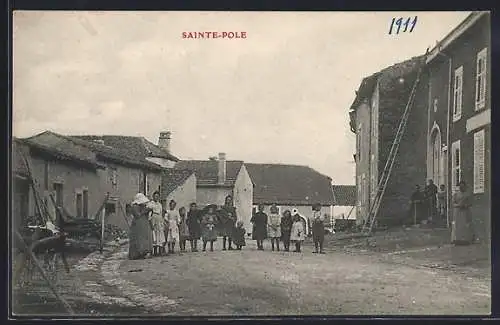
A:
[128,193,153,260]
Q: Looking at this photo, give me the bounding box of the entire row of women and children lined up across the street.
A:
[129,192,325,259]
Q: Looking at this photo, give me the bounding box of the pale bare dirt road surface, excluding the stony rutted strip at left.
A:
[116,237,491,316]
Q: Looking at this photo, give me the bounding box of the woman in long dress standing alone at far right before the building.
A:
[451,181,474,245]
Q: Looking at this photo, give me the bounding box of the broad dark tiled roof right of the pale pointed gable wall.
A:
[245,163,334,205]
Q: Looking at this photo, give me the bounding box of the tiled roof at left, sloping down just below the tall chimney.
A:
[72,135,179,161]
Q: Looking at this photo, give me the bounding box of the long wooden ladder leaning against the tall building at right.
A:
[361,57,425,235]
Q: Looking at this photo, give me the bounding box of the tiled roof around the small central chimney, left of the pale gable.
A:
[174,160,243,187]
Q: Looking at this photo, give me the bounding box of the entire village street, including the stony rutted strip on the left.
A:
[13,232,491,316]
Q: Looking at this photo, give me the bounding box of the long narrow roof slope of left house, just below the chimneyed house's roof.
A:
[25,131,162,171]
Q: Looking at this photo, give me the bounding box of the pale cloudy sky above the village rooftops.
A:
[12,11,469,184]
